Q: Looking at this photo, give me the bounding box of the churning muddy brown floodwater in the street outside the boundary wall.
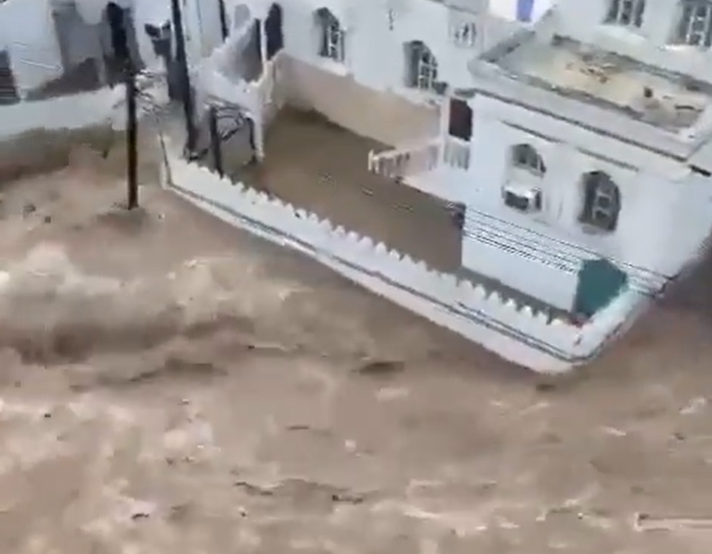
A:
[0,151,712,554]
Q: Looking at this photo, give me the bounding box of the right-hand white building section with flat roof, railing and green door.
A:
[372,0,712,316]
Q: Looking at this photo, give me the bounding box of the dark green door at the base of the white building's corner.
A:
[574,258,628,317]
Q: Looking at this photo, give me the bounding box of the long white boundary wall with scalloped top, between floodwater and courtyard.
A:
[166,149,647,373]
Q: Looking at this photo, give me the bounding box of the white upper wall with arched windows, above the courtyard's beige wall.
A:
[217,0,516,102]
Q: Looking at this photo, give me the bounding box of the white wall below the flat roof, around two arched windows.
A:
[458,96,712,307]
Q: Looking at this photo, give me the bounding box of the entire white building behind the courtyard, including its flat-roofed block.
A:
[184,0,712,370]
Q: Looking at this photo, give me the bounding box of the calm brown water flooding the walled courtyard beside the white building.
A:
[207,107,461,273]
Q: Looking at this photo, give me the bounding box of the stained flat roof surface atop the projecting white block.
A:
[483,33,712,132]
